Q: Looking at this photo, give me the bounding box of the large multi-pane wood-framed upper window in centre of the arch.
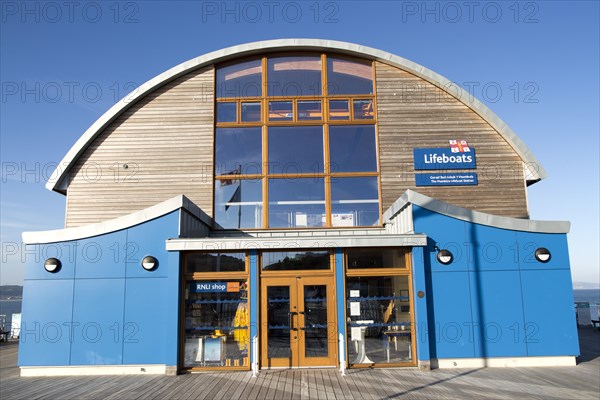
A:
[213,53,381,229]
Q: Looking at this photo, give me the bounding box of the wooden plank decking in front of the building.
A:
[0,329,600,400]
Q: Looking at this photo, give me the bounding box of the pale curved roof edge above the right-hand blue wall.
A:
[383,189,571,233]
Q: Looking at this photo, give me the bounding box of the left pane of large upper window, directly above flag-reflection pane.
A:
[215,127,262,175]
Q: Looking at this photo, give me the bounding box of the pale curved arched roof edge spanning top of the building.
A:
[46,39,546,193]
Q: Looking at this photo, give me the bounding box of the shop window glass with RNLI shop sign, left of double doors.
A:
[183,279,250,367]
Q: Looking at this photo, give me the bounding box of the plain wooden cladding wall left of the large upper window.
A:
[65,67,214,227]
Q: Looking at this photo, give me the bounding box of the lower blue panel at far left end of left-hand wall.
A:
[18,279,73,366]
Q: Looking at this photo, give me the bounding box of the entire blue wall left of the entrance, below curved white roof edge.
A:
[19,211,180,366]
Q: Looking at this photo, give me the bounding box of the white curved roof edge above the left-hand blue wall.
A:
[22,195,212,244]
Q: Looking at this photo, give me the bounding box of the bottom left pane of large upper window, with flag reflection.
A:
[215,179,262,229]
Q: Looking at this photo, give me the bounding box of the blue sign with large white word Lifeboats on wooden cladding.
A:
[413,147,477,171]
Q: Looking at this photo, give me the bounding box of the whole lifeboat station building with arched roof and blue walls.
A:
[18,39,579,376]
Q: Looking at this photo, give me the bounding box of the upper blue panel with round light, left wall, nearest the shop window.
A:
[122,211,179,278]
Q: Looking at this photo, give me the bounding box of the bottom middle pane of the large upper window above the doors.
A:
[269,178,325,228]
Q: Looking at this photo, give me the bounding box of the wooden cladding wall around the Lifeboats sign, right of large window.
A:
[375,62,529,218]
